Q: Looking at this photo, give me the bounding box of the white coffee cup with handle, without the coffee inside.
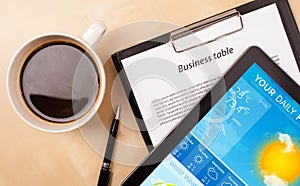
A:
[6,21,106,133]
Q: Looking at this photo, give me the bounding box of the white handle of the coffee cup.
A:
[81,20,106,49]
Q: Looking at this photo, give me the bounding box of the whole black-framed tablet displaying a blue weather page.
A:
[123,47,300,186]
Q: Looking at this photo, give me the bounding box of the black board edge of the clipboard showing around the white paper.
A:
[112,0,300,152]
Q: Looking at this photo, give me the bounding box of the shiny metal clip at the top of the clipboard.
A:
[170,9,244,53]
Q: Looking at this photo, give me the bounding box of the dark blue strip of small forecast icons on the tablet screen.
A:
[171,134,245,186]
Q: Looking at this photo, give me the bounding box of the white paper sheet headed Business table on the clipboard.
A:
[122,4,300,146]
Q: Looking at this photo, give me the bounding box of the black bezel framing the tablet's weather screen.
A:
[123,47,300,185]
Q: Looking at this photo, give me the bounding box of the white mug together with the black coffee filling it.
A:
[7,21,106,133]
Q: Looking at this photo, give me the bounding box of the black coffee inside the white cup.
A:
[21,41,100,123]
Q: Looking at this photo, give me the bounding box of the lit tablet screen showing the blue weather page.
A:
[142,63,300,186]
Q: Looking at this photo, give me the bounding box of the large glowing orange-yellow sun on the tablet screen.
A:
[260,141,300,183]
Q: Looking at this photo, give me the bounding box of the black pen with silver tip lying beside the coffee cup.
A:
[98,105,120,186]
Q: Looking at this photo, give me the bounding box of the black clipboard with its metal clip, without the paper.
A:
[111,0,300,151]
